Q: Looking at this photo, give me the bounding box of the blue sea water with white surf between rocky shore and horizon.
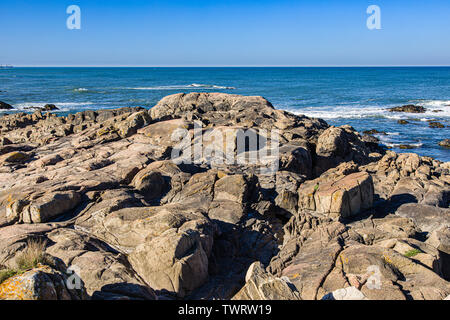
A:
[0,67,450,161]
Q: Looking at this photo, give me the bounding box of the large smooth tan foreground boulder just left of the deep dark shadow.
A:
[76,204,216,297]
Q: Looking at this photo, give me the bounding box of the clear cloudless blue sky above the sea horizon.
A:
[0,0,450,66]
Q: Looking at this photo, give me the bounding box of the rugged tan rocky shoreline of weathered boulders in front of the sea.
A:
[0,93,450,300]
